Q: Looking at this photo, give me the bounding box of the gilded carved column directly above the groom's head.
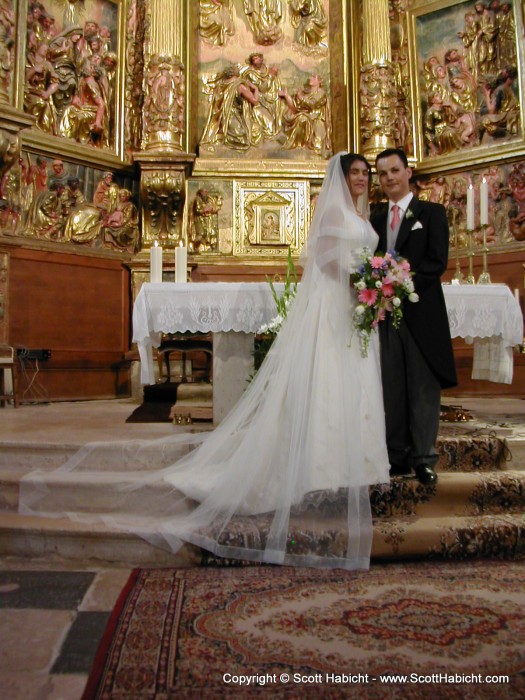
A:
[359,0,397,160]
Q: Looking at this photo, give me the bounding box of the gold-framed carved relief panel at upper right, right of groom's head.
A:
[408,0,525,170]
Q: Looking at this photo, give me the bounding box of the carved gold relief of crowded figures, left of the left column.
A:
[19,0,128,157]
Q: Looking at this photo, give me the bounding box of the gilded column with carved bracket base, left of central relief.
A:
[135,0,195,254]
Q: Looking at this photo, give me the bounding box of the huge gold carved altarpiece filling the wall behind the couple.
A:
[0,0,525,292]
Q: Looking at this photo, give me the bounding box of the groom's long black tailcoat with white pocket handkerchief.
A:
[371,197,457,389]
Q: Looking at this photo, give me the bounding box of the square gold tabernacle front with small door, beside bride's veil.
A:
[233,180,310,259]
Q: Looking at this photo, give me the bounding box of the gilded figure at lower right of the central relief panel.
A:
[279,75,332,157]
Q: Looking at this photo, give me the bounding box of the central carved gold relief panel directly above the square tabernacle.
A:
[198,0,332,161]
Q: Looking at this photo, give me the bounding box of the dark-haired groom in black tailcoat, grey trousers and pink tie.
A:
[372,148,457,485]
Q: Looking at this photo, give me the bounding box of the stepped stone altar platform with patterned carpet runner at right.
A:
[0,397,525,566]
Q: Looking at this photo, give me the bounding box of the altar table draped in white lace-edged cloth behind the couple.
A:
[133,282,523,423]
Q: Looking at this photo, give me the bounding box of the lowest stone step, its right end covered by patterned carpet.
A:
[0,513,525,567]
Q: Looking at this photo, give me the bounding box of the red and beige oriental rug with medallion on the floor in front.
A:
[83,561,525,700]
